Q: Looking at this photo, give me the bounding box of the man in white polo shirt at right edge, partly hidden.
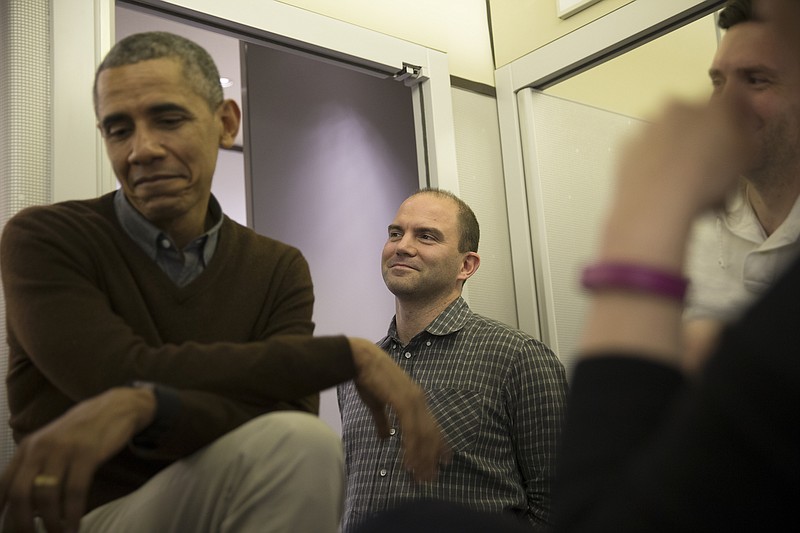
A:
[686,0,800,369]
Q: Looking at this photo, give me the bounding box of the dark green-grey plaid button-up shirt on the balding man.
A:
[338,298,567,533]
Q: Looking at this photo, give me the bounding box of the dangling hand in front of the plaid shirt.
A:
[349,338,450,481]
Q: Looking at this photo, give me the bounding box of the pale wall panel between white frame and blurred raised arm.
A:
[518,89,641,369]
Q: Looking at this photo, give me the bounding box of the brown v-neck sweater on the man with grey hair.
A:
[0,194,355,507]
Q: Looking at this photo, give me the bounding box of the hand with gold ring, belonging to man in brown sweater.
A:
[0,388,156,533]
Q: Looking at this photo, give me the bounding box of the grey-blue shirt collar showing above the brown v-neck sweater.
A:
[114,190,223,264]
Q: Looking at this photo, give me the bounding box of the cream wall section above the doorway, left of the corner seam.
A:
[279,0,494,86]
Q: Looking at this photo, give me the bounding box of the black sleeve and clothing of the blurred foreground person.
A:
[554,256,800,532]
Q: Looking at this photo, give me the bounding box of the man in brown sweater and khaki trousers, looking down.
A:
[0,32,447,532]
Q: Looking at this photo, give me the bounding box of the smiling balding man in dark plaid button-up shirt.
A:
[339,189,567,533]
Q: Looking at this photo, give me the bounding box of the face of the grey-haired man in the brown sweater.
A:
[97,58,239,229]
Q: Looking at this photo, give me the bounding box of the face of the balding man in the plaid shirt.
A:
[381,193,476,300]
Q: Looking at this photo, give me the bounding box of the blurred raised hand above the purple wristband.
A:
[616,98,759,227]
